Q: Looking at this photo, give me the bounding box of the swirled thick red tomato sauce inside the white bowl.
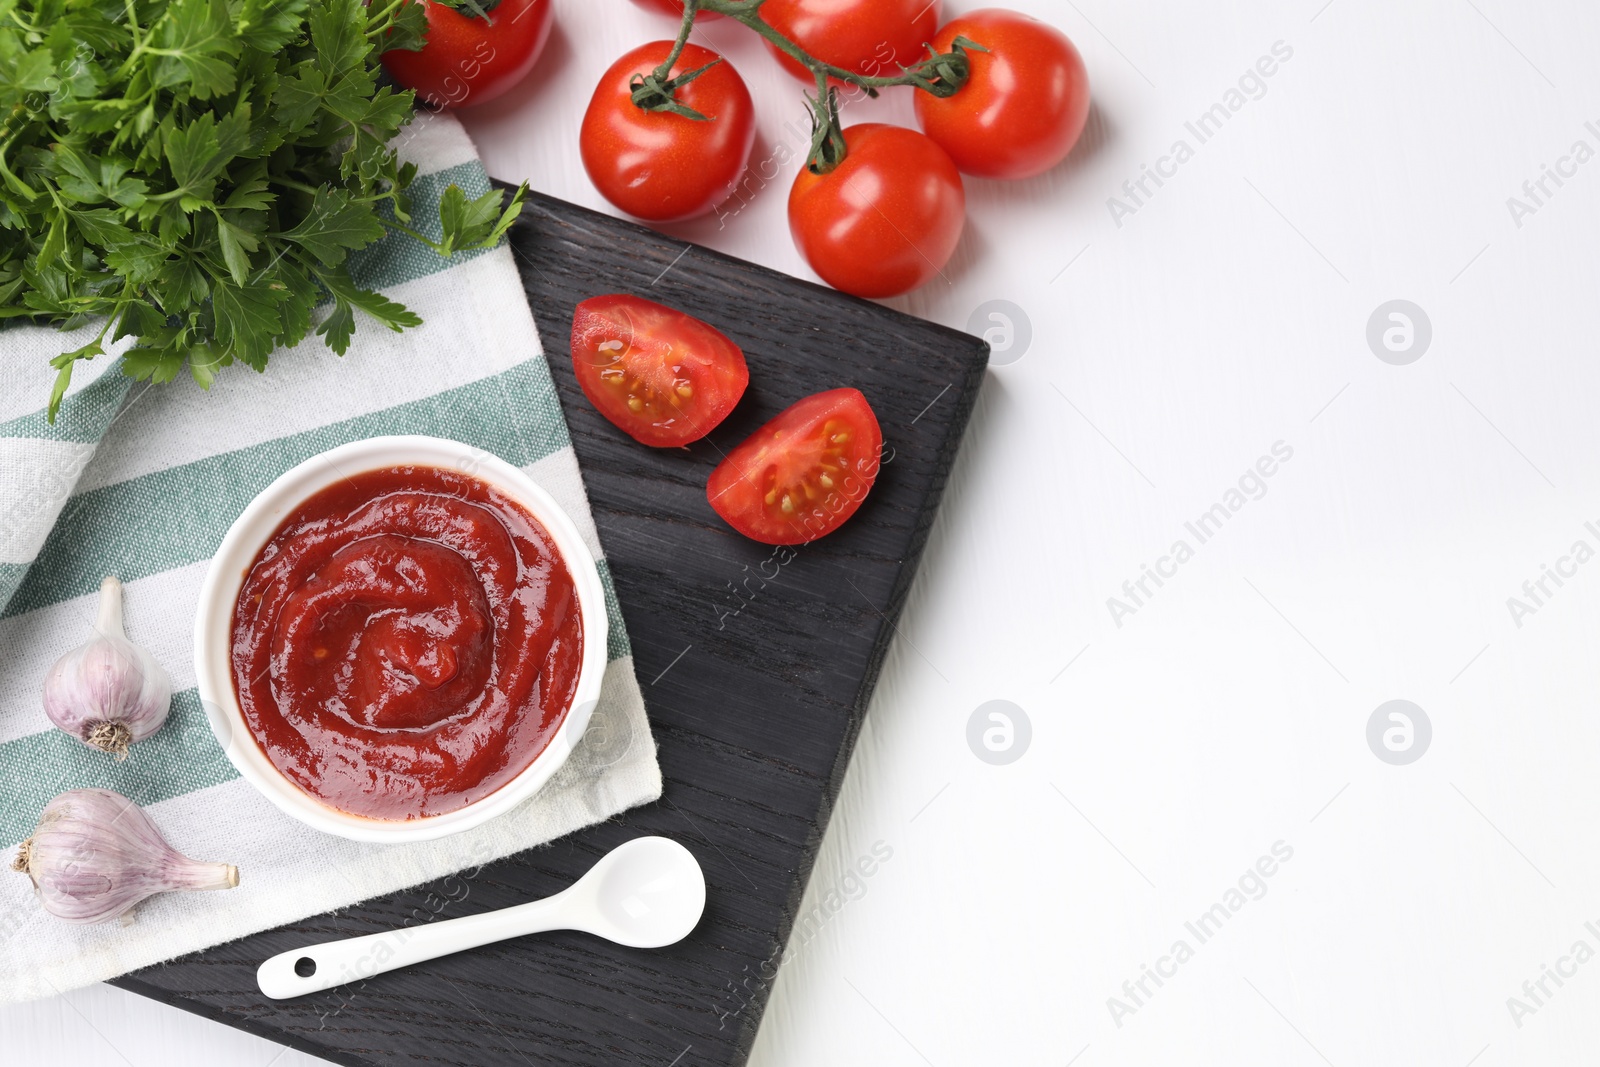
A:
[232,467,582,819]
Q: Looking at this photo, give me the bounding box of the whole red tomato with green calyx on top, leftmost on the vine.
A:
[578,40,755,222]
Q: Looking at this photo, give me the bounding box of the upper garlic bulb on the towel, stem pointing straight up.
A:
[45,577,173,760]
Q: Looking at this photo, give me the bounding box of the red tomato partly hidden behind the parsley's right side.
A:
[381,0,552,107]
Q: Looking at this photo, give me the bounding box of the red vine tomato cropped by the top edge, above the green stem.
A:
[762,0,939,83]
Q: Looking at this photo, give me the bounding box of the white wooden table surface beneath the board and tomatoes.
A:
[12,0,1600,1067]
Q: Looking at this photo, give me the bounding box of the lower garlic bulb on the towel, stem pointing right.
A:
[11,789,238,923]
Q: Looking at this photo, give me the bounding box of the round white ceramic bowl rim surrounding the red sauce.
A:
[195,437,606,843]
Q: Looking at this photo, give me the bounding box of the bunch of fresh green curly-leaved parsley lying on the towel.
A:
[0,0,523,419]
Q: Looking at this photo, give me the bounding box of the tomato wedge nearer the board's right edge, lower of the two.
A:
[706,389,883,544]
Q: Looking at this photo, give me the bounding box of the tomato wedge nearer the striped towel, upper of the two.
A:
[573,293,750,448]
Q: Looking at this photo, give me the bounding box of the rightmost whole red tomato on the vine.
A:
[917,8,1090,178]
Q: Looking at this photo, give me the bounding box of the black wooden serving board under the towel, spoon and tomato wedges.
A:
[117,187,987,1067]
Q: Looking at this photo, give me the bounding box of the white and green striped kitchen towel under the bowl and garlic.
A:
[0,115,661,1001]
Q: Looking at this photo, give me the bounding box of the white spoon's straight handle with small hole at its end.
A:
[256,893,582,1000]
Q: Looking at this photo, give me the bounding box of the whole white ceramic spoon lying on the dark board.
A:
[256,837,706,1000]
